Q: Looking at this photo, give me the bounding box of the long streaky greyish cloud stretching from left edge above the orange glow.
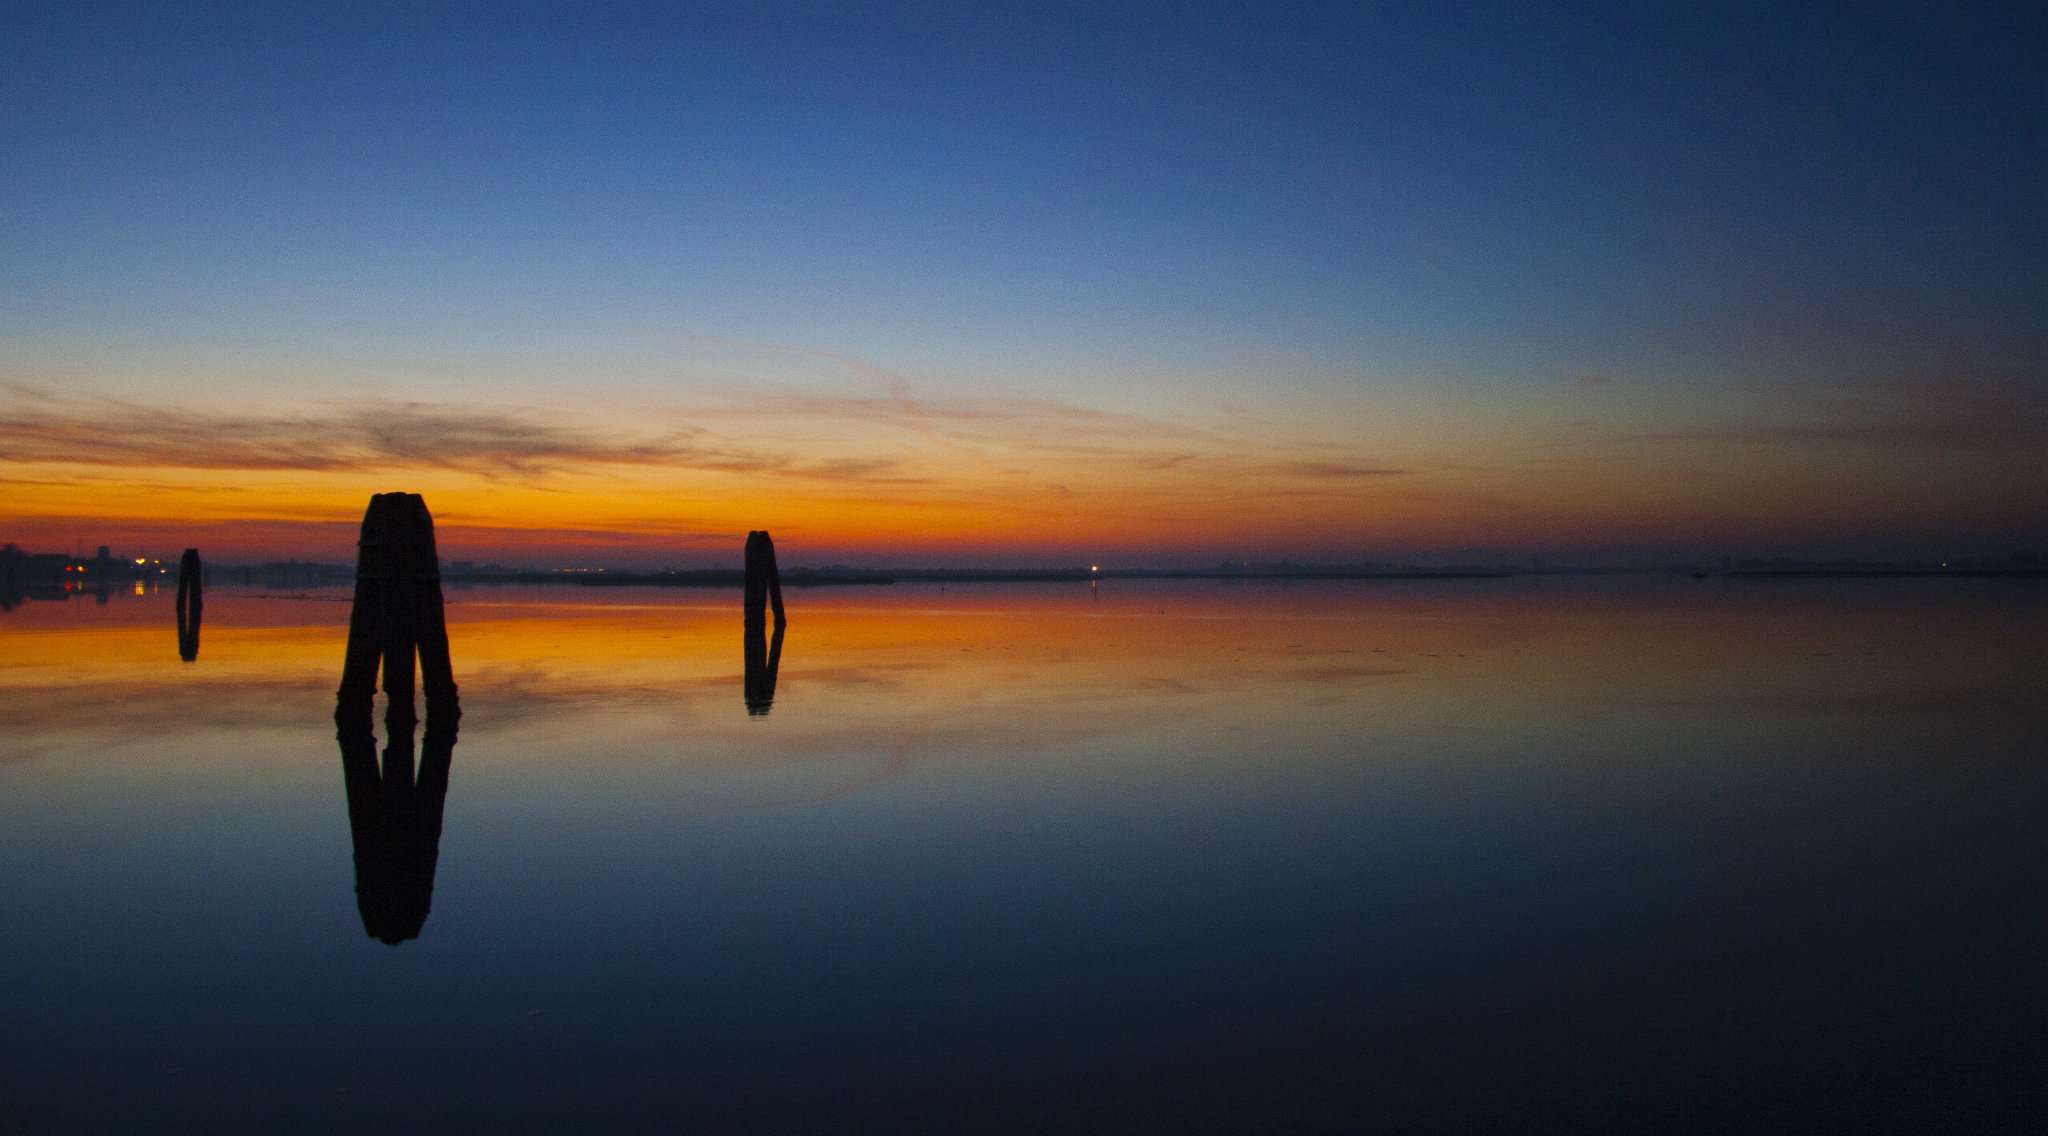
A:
[0,385,915,481]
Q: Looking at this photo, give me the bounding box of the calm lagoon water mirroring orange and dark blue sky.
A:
[0,581,2048,1132]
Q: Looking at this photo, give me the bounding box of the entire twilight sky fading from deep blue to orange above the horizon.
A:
[0,0,2048,567]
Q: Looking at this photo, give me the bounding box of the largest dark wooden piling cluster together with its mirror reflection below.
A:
[334,493,463,946]
